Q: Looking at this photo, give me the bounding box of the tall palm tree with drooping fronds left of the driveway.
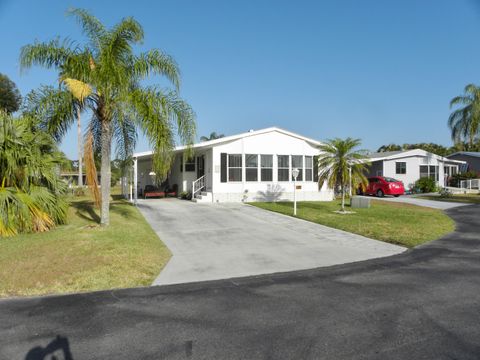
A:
[21,9,196,225]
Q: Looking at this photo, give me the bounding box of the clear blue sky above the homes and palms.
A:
[0,0,480,158]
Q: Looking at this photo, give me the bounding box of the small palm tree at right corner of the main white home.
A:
[318,138,369,212]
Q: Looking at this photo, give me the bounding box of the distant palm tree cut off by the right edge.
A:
[448,84,480,146]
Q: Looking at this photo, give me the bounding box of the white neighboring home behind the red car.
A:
[368,149,465,189]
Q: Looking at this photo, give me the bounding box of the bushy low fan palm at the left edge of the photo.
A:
[0,112,67,236]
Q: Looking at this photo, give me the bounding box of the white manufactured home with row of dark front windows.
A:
[133,127,333,203]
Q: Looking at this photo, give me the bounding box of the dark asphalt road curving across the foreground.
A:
[0,205,480,360]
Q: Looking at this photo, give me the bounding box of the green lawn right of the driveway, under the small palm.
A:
[251,200,455,247]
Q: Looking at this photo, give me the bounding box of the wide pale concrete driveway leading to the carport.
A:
[138,199,405,285]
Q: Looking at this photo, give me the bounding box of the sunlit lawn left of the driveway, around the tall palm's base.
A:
[0,197,171,297]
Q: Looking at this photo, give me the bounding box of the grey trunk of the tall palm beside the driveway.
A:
[100,120,112,226]
